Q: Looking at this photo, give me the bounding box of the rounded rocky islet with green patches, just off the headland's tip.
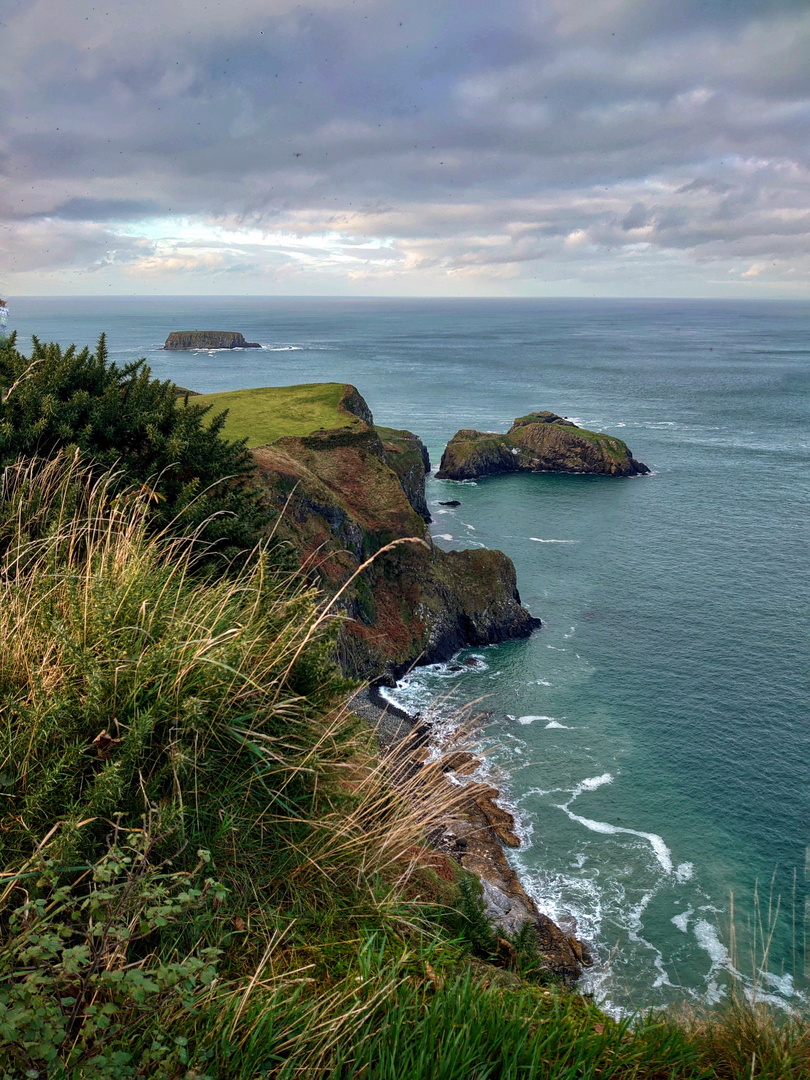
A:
[436,413,649,480]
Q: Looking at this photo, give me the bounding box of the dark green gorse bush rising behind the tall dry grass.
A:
[0,335,267,557]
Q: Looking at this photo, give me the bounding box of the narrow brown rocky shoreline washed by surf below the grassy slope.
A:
[348,685,594,984]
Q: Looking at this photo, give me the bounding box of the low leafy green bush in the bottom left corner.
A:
[0,831,224,1078]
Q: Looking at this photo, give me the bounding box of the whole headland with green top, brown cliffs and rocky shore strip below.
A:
[195,383,591,982]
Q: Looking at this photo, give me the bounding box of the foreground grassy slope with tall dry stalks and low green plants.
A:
[0,457,810,1080]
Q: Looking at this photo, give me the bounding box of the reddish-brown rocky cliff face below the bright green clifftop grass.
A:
[253,387,539,681]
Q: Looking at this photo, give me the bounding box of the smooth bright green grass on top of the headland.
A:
[192,382,360,446]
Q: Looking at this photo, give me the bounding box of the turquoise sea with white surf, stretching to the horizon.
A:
[11,298,810,1008]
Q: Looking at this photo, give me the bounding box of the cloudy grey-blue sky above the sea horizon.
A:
[0,0,810,299]
